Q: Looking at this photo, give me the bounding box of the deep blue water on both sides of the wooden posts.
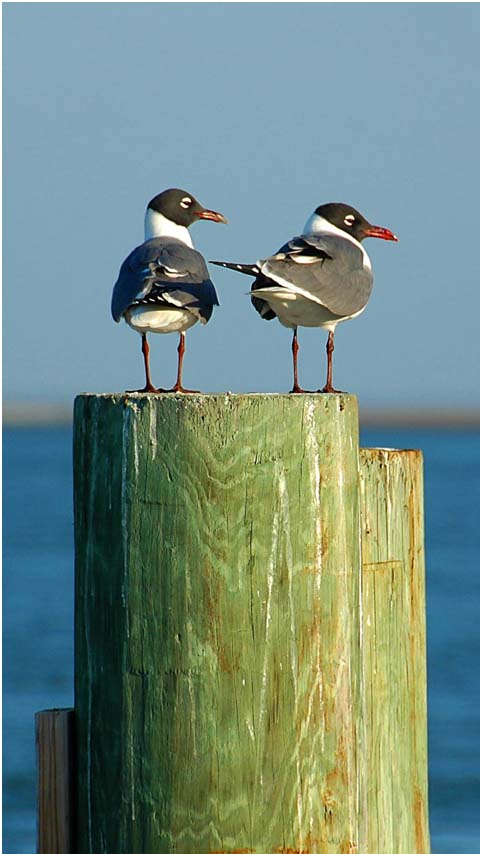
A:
[3,428,480,854]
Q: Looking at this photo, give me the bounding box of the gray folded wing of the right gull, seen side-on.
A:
[259,235,373,317]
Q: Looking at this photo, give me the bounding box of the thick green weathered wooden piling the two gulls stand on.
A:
[75,395,362,854]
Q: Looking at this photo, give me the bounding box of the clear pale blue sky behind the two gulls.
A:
[3,3,480,407]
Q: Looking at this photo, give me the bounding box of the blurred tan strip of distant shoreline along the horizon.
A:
[3,402,480,430]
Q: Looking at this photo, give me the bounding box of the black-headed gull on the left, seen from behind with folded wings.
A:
[111,189,227,393]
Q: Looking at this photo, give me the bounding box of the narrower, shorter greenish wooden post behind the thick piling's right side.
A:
[360,449,430,854]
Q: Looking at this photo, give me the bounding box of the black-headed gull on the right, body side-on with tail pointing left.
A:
[211,202,398,394]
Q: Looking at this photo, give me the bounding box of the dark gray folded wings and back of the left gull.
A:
[111,237,218,323]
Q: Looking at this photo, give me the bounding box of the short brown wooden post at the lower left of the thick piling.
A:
[35,709,76,854]
